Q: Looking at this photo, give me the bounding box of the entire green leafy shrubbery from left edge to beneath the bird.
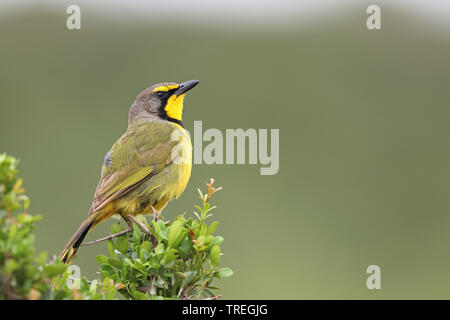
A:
[0,154,233,300]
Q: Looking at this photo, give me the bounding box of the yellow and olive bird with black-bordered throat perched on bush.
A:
[59,80,200,263]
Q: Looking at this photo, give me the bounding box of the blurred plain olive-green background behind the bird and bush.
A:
[0,1,450,299]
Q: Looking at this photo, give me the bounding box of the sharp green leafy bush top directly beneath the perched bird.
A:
[97,181,232,299]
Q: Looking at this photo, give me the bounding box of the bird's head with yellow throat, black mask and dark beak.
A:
[128,80,200,126]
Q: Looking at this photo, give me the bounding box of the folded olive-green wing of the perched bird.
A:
[90,123,177,214]
